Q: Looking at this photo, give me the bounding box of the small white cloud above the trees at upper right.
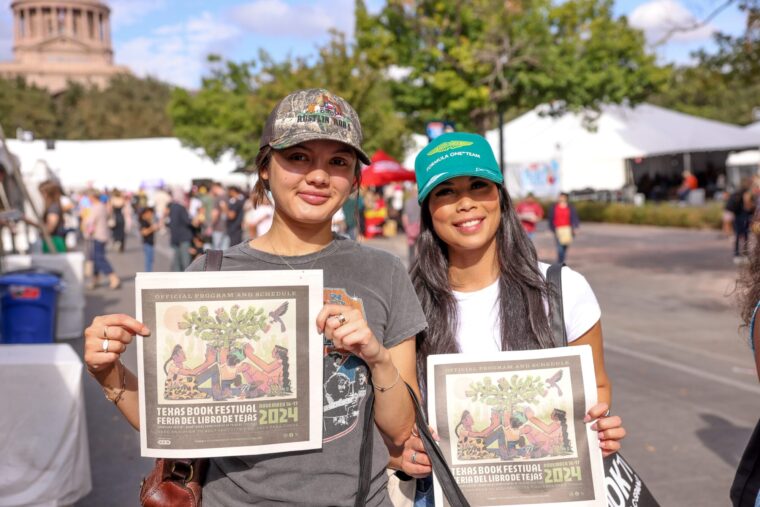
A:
[628,0,715,43]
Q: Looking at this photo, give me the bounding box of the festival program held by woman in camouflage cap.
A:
[136,270,323,458]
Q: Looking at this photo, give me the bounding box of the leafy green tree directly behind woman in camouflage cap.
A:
[169,32,409,168]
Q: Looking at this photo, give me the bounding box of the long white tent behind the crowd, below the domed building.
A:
[8,138,249,191]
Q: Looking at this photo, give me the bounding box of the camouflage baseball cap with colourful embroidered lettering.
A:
[259,88,370,165]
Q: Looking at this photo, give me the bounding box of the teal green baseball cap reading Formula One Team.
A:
[414,132,504,202]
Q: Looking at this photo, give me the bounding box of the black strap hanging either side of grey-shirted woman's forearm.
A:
[354,382,470,507]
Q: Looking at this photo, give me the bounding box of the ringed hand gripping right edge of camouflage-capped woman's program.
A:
[317,304,388,367]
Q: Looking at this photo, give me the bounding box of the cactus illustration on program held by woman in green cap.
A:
[465,375,546,415]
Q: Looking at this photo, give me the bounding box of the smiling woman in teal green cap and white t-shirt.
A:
[397,132,625,505]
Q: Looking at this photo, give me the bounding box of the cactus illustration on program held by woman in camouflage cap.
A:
[177,305,266,350]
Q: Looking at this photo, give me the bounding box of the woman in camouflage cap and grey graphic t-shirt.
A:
[85,90,426,507]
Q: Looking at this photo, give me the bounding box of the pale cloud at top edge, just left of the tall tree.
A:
[230,0,354,39]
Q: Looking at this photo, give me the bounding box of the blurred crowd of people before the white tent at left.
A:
[32,180,274,289]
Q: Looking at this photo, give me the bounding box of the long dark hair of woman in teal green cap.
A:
[410,185,553,392]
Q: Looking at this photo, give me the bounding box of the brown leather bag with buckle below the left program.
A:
[140,458,208,507]
